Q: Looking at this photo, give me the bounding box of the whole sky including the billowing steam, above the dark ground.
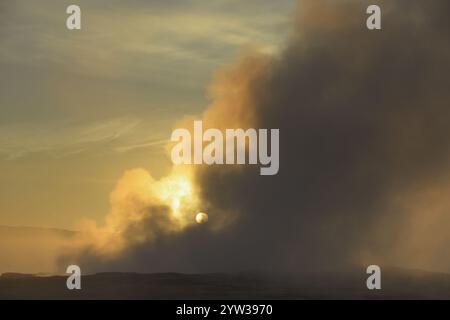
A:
[0,0,450,272]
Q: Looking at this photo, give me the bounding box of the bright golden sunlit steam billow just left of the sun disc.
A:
[70,167,200,257]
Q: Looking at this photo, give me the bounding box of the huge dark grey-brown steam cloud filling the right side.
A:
[73,0,450,272]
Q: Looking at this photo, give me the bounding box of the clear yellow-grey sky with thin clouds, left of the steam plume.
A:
[0,0,295,229]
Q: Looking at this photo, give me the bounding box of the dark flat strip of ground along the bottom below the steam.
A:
[0,269,450,299]
